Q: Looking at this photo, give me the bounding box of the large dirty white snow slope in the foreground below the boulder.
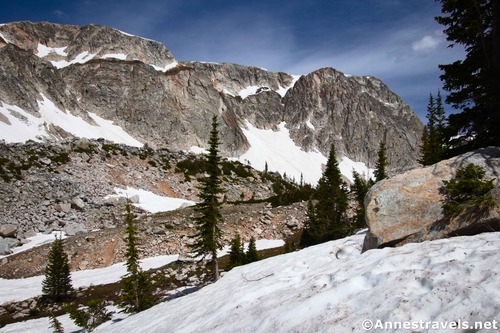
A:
[0,233,500,333]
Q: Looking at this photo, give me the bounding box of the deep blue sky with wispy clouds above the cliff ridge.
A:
[0,0,463,122]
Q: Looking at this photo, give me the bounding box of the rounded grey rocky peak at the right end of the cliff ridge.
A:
[283,68,422,170]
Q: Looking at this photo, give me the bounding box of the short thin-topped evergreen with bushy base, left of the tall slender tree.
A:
[120,202,156,312]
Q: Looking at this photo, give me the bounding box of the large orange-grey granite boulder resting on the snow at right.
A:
[363,147,500,251]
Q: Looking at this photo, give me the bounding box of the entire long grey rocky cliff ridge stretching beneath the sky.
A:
[0,22,423,175]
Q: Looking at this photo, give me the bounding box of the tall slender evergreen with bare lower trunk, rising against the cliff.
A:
[190,116,224,280]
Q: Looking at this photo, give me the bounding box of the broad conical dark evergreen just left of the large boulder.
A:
[301,144,351,246]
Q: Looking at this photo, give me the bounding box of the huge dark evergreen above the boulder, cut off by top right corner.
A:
[436,0,500,150]
